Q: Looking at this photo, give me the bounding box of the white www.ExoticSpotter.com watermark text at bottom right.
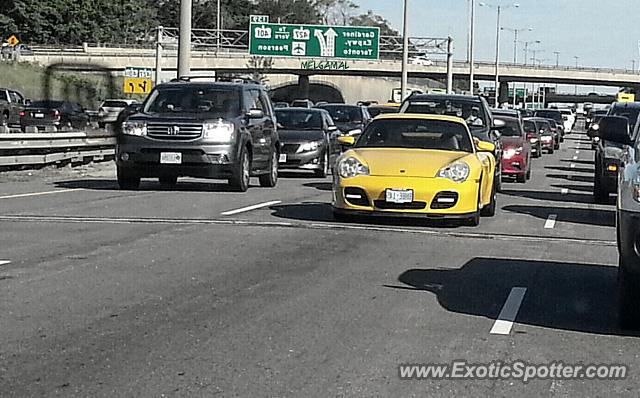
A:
[398,360,628,383]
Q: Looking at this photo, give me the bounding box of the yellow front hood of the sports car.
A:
[353,148,471,178]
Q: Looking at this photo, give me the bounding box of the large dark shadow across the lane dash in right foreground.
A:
[386,258,640,337]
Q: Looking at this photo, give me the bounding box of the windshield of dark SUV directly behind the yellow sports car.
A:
[401,99,489,129]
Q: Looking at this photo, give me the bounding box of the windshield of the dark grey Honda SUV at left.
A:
[143,86,240,115]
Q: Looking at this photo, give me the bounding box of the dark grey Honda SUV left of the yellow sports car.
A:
[116,78,280,192]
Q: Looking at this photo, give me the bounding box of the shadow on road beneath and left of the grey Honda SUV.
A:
[54,179,248,192]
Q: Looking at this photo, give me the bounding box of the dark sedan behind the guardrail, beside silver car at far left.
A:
[20,101,89,132]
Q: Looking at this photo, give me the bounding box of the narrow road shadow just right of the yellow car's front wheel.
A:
[502,205,616,227]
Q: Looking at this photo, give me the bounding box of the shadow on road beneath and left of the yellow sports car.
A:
[269,202,462,229]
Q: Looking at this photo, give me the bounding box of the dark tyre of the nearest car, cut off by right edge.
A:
[616,255,640,329]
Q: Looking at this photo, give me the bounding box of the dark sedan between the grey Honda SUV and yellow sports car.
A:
[276,108,340,177]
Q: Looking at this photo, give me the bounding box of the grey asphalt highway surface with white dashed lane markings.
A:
[0,123,640,397]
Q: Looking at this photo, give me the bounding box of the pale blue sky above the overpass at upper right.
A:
[354,0,640,69]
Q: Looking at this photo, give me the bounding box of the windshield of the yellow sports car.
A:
[356,119,473,152]
